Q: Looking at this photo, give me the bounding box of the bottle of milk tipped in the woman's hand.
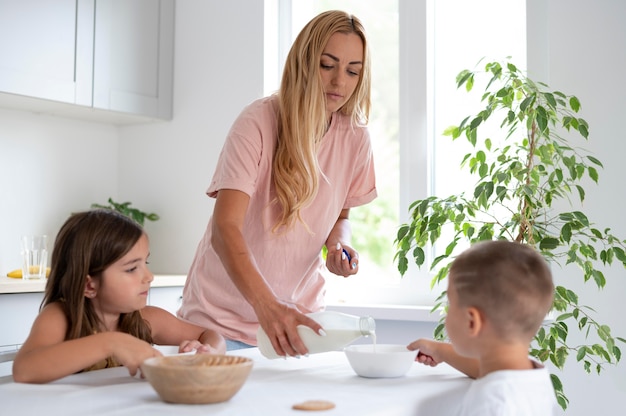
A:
[257,311,376,358]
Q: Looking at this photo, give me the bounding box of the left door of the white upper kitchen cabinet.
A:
[0,0,94,105]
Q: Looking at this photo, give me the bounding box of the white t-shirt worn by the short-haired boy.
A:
[458,360,560,416]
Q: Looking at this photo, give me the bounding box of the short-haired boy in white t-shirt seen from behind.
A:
[408,241,558,416]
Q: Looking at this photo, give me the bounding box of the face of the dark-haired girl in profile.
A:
[86,234,154,323]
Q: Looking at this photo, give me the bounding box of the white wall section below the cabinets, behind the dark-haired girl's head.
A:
[0,109,118,272]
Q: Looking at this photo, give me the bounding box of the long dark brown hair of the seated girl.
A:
[41,209,152,343]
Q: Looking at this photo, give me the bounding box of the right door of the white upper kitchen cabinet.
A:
[93,0,174,119]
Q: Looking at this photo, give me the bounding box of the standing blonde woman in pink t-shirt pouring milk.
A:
[178,11,376,356]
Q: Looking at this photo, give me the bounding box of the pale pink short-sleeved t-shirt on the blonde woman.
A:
[178,96,376,345]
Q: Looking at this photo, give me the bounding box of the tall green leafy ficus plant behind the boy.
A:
[395,60,626,409]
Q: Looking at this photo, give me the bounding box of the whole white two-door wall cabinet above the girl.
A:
[0,0,174,119]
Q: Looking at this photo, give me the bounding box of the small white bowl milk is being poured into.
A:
[344,344,417,378]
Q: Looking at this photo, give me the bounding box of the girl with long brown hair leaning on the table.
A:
[13,210,226,383]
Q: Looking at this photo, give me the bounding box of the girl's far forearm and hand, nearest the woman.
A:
[141,306,226,354]
